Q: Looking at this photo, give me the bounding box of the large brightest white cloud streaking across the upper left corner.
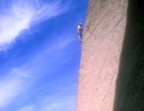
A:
[0,0,68,50]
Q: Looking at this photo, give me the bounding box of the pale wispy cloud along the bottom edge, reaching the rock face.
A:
[18,83,76,111]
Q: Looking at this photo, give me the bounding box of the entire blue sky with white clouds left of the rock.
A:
[0,0,88,111]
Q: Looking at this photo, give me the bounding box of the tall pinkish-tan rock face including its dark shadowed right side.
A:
[76,0,144,111]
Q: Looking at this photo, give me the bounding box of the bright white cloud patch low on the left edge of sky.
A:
[0,69,30,108]
